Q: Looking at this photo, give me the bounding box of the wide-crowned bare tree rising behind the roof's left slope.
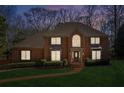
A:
[24,7,57,31]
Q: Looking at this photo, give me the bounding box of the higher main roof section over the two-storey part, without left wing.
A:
[45,22,106,37]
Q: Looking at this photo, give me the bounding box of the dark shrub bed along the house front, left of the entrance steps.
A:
[0,60,68,70]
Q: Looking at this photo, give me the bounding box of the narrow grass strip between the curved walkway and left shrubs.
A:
[0,68,69,80]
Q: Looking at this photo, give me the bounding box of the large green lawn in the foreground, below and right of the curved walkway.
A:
[0,60,124,87]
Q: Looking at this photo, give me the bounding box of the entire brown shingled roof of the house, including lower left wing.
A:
[15,22,106,48]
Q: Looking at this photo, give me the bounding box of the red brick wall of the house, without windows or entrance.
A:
[10,35,109,62]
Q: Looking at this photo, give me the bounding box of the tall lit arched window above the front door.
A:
[72,35,81,47]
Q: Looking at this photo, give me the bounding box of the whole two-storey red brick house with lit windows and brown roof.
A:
[10,22,109,63]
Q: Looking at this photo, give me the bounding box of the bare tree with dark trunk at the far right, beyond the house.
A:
[103,5,124,46]
